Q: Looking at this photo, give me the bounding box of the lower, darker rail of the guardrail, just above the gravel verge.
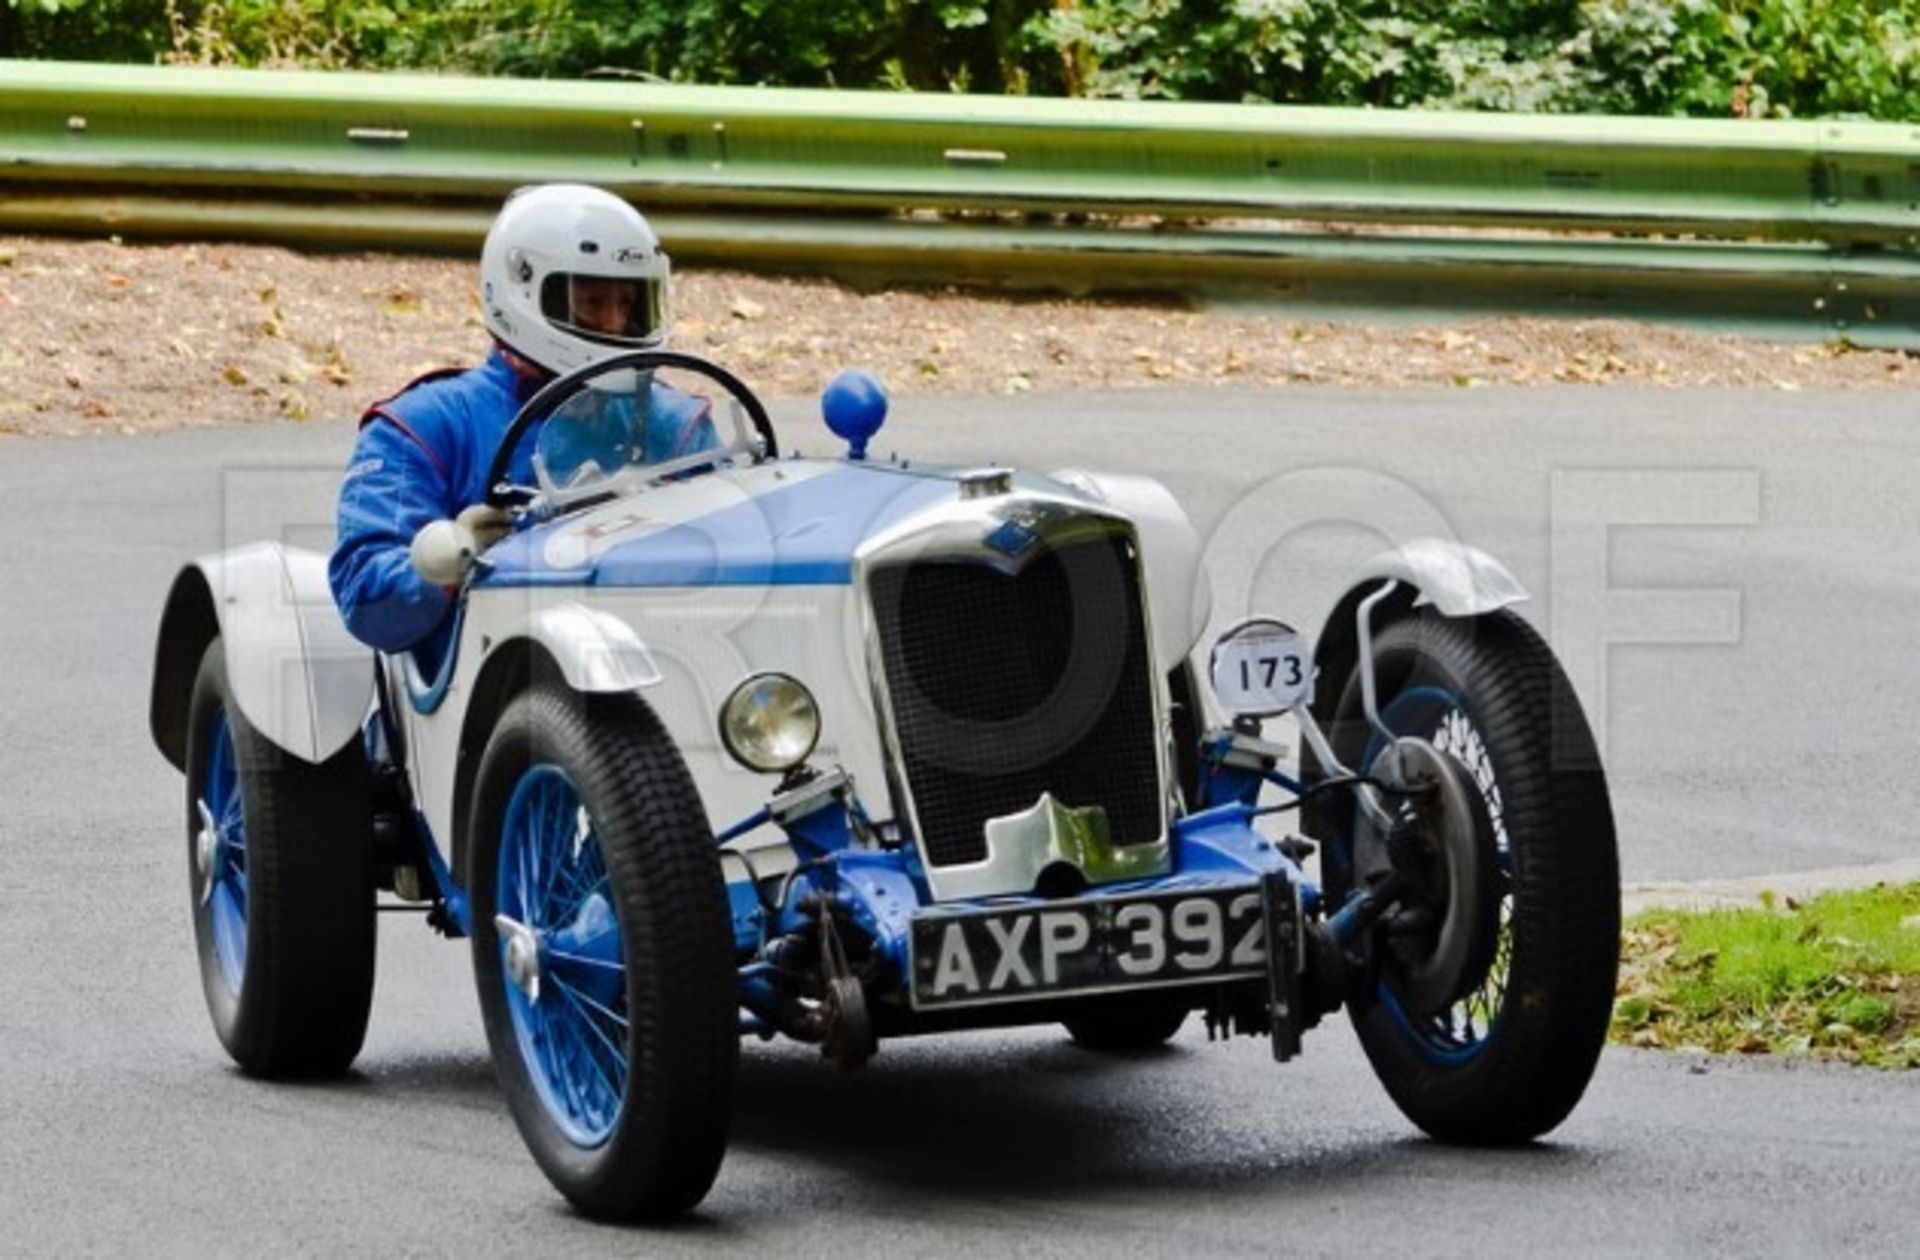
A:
[0,194,1920,350]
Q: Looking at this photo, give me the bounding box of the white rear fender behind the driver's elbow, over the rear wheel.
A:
[180,542,374,763]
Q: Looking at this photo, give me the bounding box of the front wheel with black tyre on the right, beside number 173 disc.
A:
[1315,611,1620,1145]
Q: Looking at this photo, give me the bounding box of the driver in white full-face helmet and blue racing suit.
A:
[326,184,718,674]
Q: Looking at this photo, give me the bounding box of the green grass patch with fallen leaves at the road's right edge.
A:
[1613,884,1920,1068]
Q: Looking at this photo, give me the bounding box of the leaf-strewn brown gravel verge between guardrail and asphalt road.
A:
[0,236,1920,436]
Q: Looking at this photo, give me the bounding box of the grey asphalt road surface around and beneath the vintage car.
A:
[0,390,1920,1256]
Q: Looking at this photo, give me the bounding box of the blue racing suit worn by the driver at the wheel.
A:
[326,348,718,676]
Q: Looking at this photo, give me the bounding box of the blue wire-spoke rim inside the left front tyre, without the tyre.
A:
[495,764,632,1147]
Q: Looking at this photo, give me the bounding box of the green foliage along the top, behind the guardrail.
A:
[0,0,1920,121]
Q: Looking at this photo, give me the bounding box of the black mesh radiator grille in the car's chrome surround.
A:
[868,536,1164,866]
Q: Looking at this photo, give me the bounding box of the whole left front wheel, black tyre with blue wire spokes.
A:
[467,686,739,1222]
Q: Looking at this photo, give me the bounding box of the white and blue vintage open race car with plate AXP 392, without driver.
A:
[152,351,1619,1220]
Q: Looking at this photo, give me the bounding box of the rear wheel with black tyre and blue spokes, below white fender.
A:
[186,638,374,1078]
